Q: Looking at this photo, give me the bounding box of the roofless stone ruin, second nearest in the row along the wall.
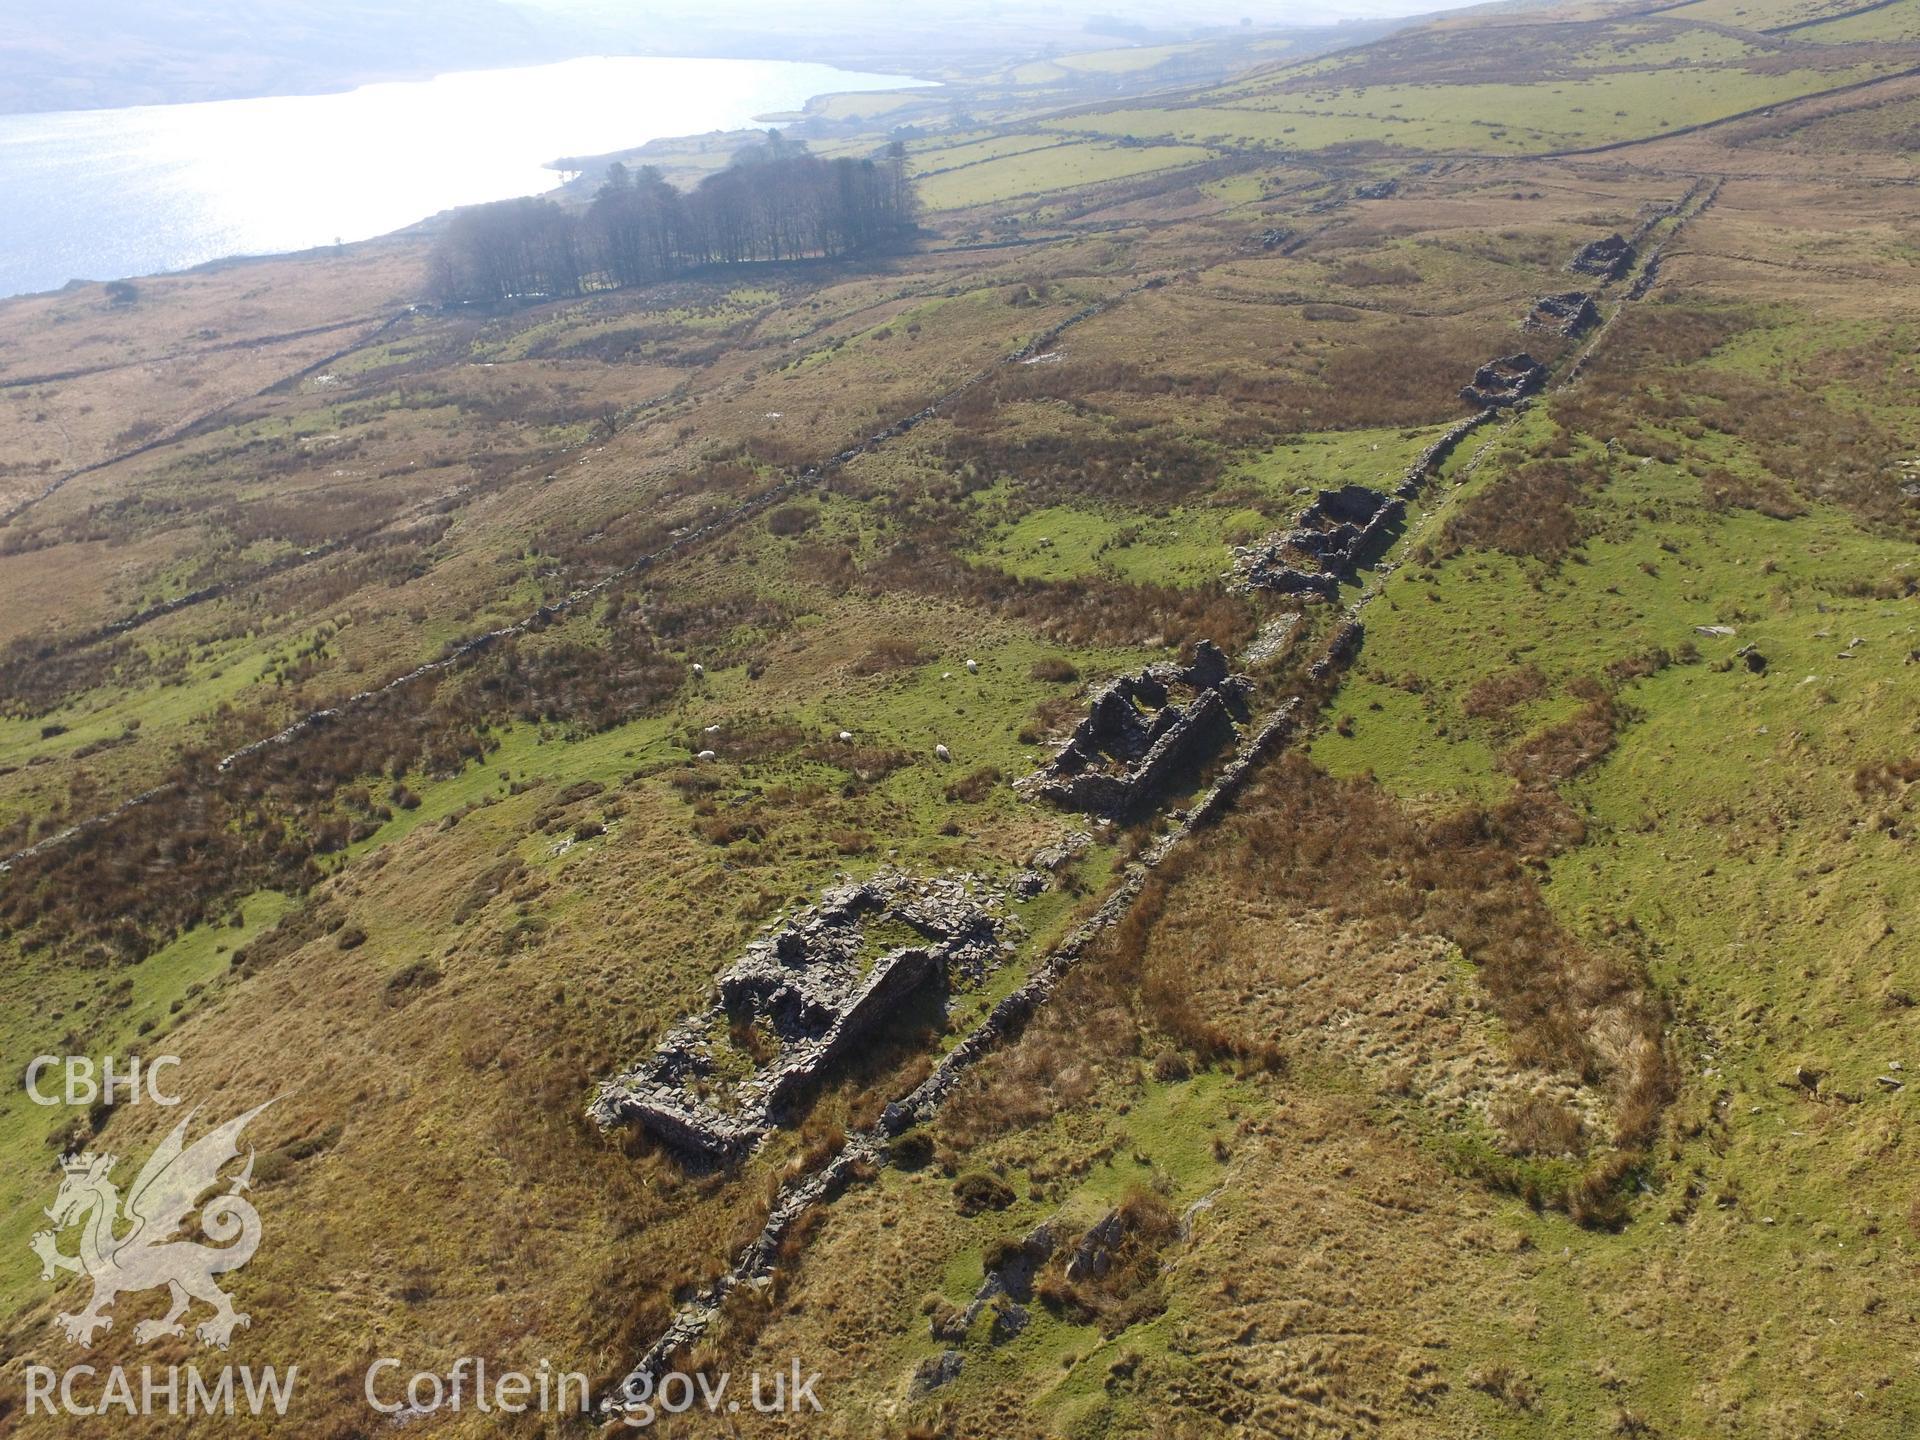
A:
[1018,641,1252,818]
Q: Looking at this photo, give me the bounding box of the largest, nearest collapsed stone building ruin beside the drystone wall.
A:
[589,874,1010,1162]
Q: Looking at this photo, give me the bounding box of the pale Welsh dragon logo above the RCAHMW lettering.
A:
[33,1100,273,1348]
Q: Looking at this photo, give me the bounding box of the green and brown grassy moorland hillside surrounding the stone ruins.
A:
[0,0,1920,1440]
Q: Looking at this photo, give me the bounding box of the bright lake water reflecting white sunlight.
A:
[0,58,920,296]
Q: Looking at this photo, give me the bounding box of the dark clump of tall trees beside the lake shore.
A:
[430,131,916,303]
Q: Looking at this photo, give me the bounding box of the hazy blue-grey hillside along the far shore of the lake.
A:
[0,0,1443,113]
